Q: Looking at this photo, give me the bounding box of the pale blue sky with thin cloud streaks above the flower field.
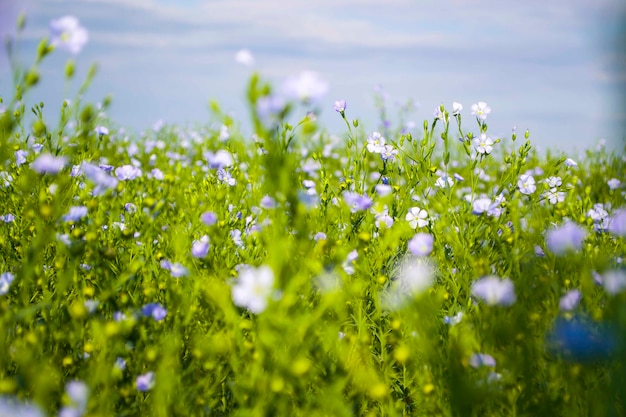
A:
[0,0,626,150]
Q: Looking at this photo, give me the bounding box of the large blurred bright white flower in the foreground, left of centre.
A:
[232,266,274,314]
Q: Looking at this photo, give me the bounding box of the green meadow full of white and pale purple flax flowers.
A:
[0,13,626,417]
